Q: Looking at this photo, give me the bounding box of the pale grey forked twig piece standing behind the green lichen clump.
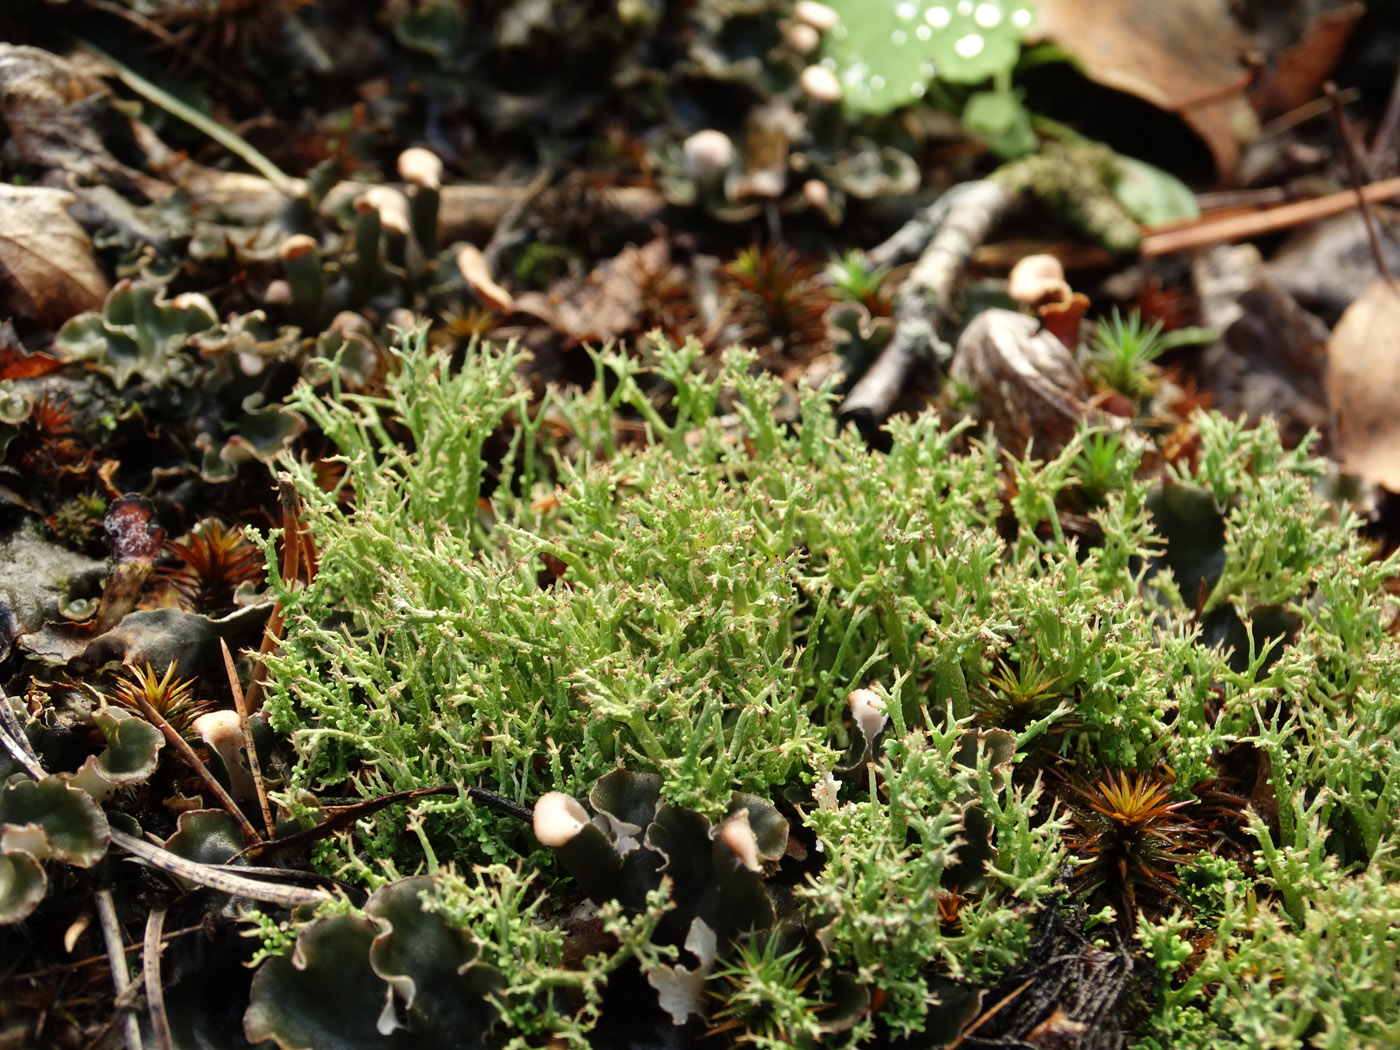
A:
[837,181,1015,438]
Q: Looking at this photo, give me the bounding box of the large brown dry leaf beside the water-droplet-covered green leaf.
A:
[1036,0,1252,182]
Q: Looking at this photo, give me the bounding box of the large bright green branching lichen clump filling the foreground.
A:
[257,336,1400,1046]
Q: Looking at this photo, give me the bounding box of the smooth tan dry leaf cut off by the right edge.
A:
[1327,277,1400,491]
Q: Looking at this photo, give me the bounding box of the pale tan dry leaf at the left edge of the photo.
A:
[0,185,108,328]
